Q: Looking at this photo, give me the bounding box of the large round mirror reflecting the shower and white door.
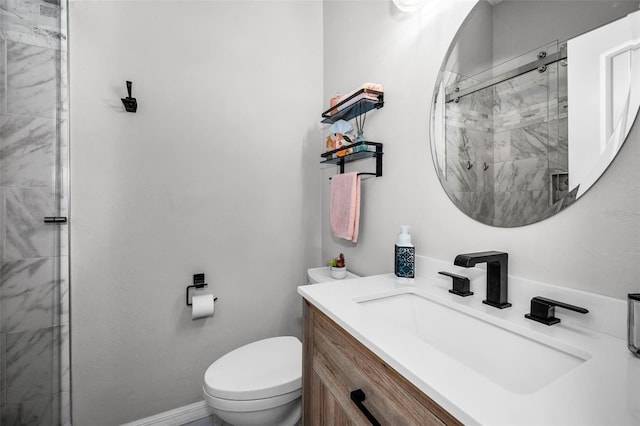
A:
[431,0,640,227]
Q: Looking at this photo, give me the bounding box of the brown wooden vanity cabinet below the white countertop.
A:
[302,301,461,426]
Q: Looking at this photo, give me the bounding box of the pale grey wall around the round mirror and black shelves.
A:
[324,0,640,298]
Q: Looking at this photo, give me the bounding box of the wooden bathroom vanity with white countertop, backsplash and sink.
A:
[298,256,640,425]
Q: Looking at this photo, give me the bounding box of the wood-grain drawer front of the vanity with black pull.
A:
[311,307,460,425]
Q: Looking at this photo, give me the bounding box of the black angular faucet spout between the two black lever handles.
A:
[453,251,511,309]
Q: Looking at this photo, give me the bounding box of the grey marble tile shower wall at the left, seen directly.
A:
[0,0,70,426]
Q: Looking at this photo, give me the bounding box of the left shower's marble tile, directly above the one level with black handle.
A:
[0,116,57,188]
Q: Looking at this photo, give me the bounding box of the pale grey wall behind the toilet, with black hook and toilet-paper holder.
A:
[70,1,322,425]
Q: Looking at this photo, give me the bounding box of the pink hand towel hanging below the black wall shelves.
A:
[330,173,360,243]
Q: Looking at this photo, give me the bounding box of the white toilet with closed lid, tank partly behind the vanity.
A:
[202,268,357,426]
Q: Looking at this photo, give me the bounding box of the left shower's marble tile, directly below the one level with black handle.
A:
[0,257,68,333]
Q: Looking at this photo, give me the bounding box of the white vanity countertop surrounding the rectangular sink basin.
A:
[298,264,640,425]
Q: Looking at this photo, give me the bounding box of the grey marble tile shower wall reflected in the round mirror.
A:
[446,63,567,226]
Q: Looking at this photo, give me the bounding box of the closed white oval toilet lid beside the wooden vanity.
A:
[204,336,302,401]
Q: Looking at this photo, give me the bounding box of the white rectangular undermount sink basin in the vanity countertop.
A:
[354,288,591,394]
